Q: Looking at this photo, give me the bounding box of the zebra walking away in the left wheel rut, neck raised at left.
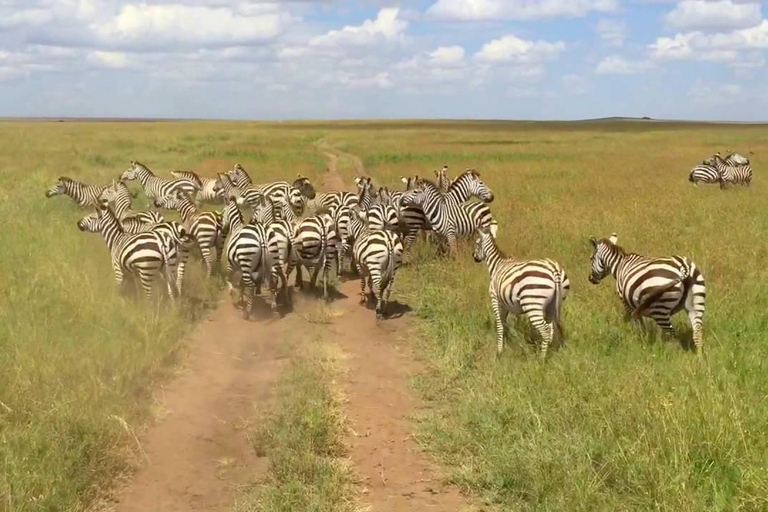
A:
[222,198,279,320]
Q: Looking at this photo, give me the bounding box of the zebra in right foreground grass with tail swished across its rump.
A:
[589,233,706,354]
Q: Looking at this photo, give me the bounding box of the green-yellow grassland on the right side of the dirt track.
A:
[322,123,768,511]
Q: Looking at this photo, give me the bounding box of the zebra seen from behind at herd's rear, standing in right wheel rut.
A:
[352,222,403,320]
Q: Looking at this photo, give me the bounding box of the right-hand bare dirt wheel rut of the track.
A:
[320,141,478,512]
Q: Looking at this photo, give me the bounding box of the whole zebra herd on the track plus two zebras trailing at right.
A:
[46,162,708,357]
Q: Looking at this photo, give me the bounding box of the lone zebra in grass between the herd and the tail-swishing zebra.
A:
[473,228,570,358]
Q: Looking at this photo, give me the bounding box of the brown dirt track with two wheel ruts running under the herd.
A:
[106,146,469,512]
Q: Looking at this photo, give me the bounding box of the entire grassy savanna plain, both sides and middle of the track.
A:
[0,121,768,511]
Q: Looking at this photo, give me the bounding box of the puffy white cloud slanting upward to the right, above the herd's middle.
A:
[309,8,408,47]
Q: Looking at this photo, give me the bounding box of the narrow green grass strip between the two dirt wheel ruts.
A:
[236,344,357,512]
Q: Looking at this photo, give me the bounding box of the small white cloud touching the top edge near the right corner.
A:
[664,0,763,30]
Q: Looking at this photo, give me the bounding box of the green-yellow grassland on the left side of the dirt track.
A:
[0,122,325,511]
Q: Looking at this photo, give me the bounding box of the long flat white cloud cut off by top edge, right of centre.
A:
[427,0,618,21]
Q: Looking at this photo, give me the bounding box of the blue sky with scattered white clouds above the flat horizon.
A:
[0,0,768,121]
